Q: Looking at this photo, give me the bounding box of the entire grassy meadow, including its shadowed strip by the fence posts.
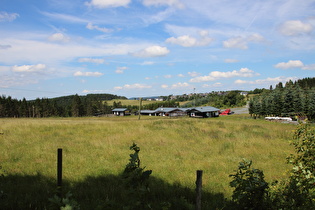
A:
[0,115,295,209]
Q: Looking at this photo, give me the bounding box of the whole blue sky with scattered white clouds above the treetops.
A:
[0,0,315,99]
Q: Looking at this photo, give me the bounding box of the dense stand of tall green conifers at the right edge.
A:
[249,78,315,121]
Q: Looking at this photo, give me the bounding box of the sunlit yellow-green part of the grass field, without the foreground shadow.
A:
[0,115,295,209]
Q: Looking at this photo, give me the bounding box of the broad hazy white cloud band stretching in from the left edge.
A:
[0,34,141,66]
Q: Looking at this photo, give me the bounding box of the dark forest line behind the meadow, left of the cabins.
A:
[0,94,126,118]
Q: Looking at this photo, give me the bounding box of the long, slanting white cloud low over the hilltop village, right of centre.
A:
[190,68,260,82]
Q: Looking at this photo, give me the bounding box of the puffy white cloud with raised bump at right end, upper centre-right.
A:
[165,31,213,47]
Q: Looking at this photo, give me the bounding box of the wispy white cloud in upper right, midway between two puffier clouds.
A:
[223,34,265,50]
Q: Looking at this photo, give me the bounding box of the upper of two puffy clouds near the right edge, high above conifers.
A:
[279,20,313,36]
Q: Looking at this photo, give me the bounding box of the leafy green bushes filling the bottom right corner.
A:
[230,125,315,209]
